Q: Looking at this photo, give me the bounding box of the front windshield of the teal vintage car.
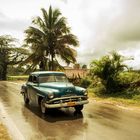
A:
[39,75,68,83]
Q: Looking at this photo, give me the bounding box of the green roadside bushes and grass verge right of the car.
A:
[79,52,140,106]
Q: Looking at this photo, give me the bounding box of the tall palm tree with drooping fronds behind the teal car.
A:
[25,6,78,70]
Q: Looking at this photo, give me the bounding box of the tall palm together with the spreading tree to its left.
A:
[0,6,79,80]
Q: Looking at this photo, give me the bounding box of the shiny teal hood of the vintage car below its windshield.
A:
[36,82,76,96]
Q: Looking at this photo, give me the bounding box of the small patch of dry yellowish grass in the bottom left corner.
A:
[0,123,11,140]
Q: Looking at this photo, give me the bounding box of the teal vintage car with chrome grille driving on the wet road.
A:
[21,71,88,114]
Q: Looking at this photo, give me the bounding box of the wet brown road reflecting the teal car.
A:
[0,82,140,140]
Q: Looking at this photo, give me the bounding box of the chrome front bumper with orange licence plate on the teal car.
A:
[45,100,89,108]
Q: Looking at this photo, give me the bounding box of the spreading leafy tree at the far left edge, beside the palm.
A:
[0,35,28,80]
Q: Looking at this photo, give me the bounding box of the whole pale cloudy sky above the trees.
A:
[0,0,140,68]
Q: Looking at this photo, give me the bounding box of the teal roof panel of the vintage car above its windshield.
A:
[30,71,64,75]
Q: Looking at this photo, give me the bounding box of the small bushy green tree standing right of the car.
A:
[90,52,127,93]
